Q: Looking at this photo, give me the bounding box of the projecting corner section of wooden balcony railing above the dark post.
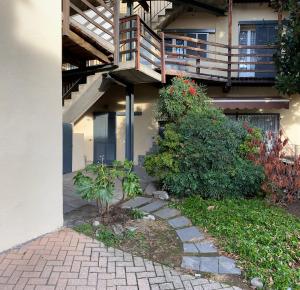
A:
[119,15,165,82]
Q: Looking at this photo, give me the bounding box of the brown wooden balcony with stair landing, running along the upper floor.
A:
[63,0,276,87]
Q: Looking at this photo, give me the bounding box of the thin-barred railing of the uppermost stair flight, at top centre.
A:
[133,1,172,29]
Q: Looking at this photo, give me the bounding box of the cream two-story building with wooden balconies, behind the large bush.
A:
[63,0,300,172]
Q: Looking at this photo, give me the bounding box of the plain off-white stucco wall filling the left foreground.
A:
[0,0,63,252]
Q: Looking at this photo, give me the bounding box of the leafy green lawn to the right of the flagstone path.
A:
[175,197,300,290]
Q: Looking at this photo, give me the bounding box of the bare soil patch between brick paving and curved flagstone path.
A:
[74,206,182,268]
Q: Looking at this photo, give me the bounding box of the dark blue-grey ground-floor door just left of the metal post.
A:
[94,113,116,164]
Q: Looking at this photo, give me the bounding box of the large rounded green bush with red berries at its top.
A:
[145,78,263,198]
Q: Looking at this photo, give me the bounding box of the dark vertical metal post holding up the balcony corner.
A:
[125,85,134,161]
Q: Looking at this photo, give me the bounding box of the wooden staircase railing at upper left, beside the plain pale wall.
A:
[62,0,120,64]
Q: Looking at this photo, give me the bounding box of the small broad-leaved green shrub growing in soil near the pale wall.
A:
[74,162,120,216]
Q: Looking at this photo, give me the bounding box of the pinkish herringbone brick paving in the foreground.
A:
[0,229,244,290]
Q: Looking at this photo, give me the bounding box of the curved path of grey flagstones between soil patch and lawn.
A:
[122,196,241,275]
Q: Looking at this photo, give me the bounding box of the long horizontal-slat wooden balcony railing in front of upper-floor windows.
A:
[165,34,276,82]
